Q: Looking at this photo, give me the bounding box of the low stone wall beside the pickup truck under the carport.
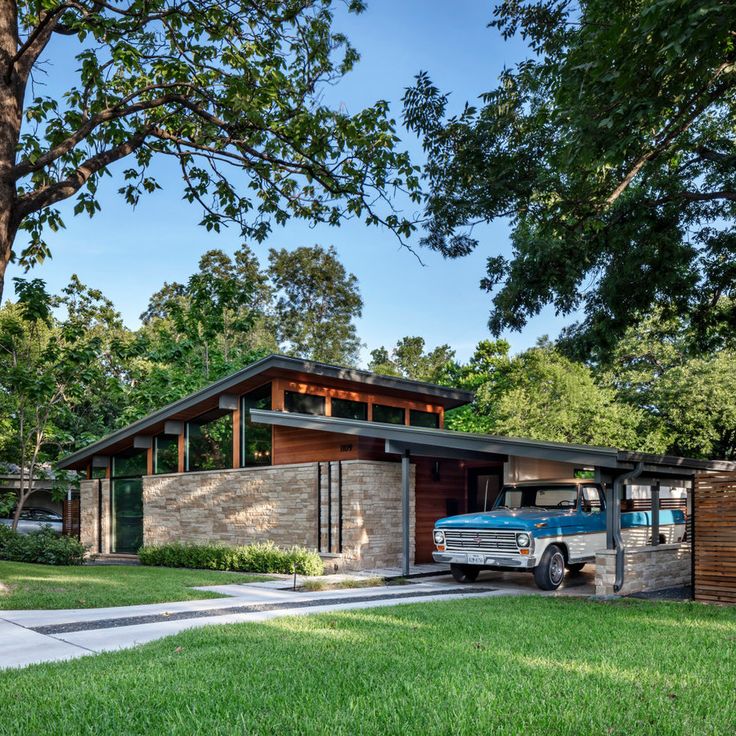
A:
[595,543,692,595]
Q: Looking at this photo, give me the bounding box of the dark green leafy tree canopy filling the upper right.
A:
[404,0,736,353]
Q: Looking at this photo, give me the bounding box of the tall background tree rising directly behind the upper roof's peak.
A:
[268,245,363,365]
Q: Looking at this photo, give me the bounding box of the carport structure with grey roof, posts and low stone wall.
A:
[251,409,736,594]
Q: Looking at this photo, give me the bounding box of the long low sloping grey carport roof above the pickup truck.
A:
[250,409,736,475]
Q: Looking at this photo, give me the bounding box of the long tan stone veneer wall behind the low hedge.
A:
[143,460,414,571]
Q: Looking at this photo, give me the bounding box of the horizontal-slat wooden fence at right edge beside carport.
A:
[693,473,736,603]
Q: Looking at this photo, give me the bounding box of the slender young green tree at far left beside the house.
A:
[0,279,115,529]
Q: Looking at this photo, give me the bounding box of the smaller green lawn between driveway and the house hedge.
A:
[0,562,270,608]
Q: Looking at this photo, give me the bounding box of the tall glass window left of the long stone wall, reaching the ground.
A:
[110,450,147,554]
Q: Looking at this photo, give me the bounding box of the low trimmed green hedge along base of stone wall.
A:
[138,542,324,575]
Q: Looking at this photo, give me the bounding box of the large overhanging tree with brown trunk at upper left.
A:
[0,0,418,296]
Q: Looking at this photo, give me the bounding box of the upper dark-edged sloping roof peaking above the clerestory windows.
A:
[57,355,473,468]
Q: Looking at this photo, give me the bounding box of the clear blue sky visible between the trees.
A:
[6,0,565,359]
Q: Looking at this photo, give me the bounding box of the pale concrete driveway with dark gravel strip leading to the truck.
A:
[0,573,592,668]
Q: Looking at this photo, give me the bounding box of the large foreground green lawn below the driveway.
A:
[0,596,736,736]
